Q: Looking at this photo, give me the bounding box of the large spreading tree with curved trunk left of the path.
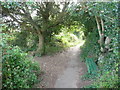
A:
[0,2,69,53]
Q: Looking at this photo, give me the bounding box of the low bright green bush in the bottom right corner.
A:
[85,71,120,88]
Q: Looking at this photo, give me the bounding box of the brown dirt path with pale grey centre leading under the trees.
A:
[35,45,91,88]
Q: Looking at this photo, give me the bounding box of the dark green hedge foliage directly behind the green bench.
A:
[81,30,100,61]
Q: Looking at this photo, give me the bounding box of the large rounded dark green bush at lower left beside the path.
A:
[2,46,40,89]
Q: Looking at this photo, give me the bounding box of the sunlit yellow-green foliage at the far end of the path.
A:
[40,22,84,55]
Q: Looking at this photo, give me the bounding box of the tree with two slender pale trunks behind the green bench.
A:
[69,2,117,52]
